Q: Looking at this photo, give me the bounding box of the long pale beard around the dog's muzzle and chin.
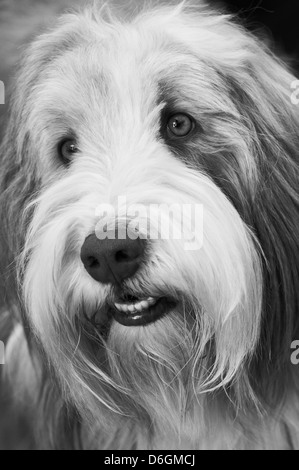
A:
[20,162,261,444]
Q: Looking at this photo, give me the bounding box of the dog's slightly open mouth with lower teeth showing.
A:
[109,294,177,326]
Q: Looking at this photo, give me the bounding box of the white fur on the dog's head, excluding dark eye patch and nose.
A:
[2,0,298,449]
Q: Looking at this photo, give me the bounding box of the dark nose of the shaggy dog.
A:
[81,234,145,284]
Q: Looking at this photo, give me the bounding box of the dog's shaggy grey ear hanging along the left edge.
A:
[0,37,46,307]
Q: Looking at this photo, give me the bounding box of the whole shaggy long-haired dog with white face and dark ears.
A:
[0,1,299,450]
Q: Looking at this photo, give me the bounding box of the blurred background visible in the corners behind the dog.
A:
[0,0,299,450]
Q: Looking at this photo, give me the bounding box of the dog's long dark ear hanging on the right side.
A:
[228,38,299,396]
